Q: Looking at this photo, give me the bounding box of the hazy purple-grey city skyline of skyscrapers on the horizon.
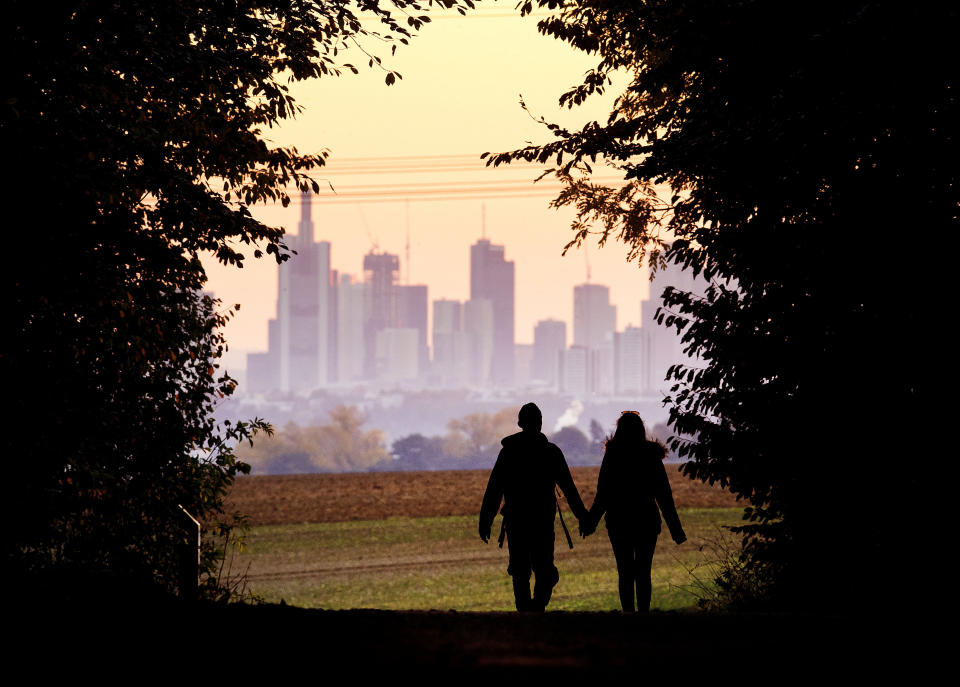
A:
[236,202,695,397]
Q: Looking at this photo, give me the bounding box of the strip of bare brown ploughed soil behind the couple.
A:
[226,465,738,525]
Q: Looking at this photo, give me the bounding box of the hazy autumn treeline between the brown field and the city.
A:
[237,405,670,475]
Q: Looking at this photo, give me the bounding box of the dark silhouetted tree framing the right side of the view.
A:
[489,0,960,608]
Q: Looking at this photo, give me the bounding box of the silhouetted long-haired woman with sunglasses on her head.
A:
[583,411,687,613]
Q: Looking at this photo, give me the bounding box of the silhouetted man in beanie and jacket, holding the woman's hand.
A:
[480,403,587,611]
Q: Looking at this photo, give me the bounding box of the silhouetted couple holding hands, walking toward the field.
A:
[480,403,686,613]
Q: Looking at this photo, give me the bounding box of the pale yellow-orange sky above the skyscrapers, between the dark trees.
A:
[206,4,648,367]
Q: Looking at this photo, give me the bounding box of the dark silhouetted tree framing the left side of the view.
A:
[0,0,471,591]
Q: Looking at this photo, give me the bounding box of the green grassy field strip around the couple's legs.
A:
[223,508,742,611]
